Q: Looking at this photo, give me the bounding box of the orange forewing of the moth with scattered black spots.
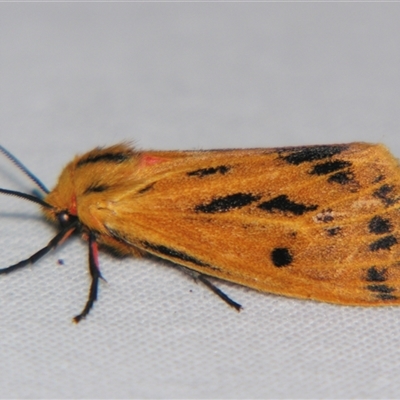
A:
[101,143,400,305]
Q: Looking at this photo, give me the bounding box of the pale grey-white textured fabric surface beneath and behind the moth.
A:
[0,3,400,398]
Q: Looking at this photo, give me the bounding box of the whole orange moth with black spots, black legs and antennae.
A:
[0,143,400,322]
